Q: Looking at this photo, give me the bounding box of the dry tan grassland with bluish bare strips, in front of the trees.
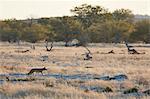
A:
[0,43,150,99]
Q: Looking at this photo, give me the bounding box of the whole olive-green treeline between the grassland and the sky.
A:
[0,4,150,46]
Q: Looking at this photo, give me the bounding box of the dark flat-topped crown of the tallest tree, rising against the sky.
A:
[71,4,108,29]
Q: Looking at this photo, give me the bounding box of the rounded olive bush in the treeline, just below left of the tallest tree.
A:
[51,16,81,46]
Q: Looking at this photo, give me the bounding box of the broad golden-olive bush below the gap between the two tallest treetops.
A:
[88,20,134,43]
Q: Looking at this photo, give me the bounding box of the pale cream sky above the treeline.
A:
[0,0,150,19]
